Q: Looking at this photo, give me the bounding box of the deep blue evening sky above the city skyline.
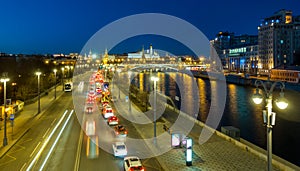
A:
[0,0,300,54]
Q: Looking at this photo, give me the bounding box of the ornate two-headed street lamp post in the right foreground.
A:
[252,80,288,171]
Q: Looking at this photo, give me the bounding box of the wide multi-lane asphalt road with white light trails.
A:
[0,86,162,171]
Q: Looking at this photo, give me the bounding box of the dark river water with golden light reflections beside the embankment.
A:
[129,73,300,166]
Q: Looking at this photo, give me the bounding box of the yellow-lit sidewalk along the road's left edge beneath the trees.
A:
[0,86,63,158]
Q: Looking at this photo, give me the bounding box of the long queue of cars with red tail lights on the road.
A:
[83,70,145,171]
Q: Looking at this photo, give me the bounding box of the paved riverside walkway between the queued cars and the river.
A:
[112,86,300,171]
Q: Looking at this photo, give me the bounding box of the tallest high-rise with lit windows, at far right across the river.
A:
[258,10,299,75]
